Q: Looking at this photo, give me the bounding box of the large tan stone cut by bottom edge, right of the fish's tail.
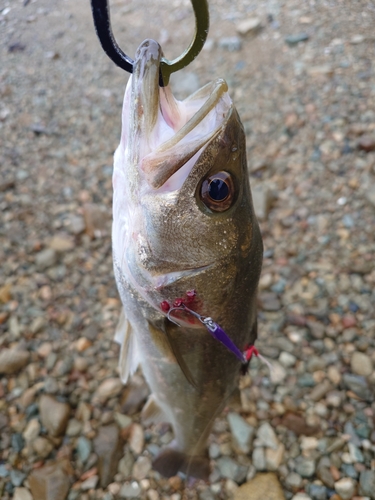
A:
[233,473,285,500]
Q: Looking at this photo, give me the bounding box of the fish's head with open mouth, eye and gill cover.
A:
[113,40,262,331]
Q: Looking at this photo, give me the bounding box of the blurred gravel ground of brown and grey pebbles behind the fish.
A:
[0,0,375,500]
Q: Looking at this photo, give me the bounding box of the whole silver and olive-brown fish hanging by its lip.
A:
[112,40,263,480]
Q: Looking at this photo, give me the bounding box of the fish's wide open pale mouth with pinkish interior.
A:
[123,40,232,191]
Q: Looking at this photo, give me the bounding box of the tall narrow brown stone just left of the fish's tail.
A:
[94,424,123,488]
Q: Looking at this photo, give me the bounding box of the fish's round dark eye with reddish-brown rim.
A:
[201,171,234,212]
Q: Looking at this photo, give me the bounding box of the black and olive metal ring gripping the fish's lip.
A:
[91,0,209,87]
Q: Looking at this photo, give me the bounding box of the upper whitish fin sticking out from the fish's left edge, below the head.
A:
[115,309,140,384]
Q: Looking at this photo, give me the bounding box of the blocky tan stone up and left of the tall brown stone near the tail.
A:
[39,394,70,437]
